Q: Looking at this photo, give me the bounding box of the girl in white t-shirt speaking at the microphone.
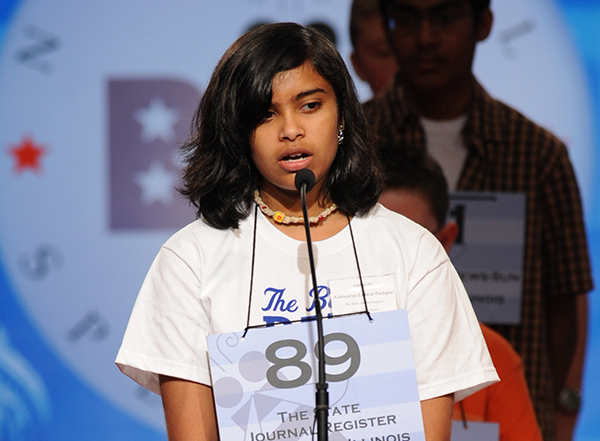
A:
[117,23,497,441]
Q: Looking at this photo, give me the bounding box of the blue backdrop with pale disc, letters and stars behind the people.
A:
[0,0,600,441]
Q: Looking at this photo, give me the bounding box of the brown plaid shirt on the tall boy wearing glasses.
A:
[364,76,593,441]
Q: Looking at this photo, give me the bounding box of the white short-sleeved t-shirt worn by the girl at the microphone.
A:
[116,205,498,400]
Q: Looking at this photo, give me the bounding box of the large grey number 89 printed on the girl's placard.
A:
[265,332,360,389]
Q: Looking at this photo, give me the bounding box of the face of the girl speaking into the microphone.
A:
[250,62,339,196]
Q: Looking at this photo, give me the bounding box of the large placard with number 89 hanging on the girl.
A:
[208,310,425,441]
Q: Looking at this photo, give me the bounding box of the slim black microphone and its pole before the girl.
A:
[295,168,329,441]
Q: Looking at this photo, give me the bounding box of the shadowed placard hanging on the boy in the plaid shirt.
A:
[449,192,526,325]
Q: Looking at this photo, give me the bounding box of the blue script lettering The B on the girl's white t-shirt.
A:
[261,285,331,326]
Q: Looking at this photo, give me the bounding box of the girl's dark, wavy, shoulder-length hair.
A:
[179,23,383,229]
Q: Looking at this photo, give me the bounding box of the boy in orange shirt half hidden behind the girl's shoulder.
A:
[379,150,542,441]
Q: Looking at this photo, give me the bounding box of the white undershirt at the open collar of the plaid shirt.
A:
[421,115,467,191]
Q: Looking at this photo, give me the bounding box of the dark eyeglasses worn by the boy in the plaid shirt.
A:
[388,1,472,34]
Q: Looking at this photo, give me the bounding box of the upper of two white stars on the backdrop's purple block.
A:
[134,98,179,142]
